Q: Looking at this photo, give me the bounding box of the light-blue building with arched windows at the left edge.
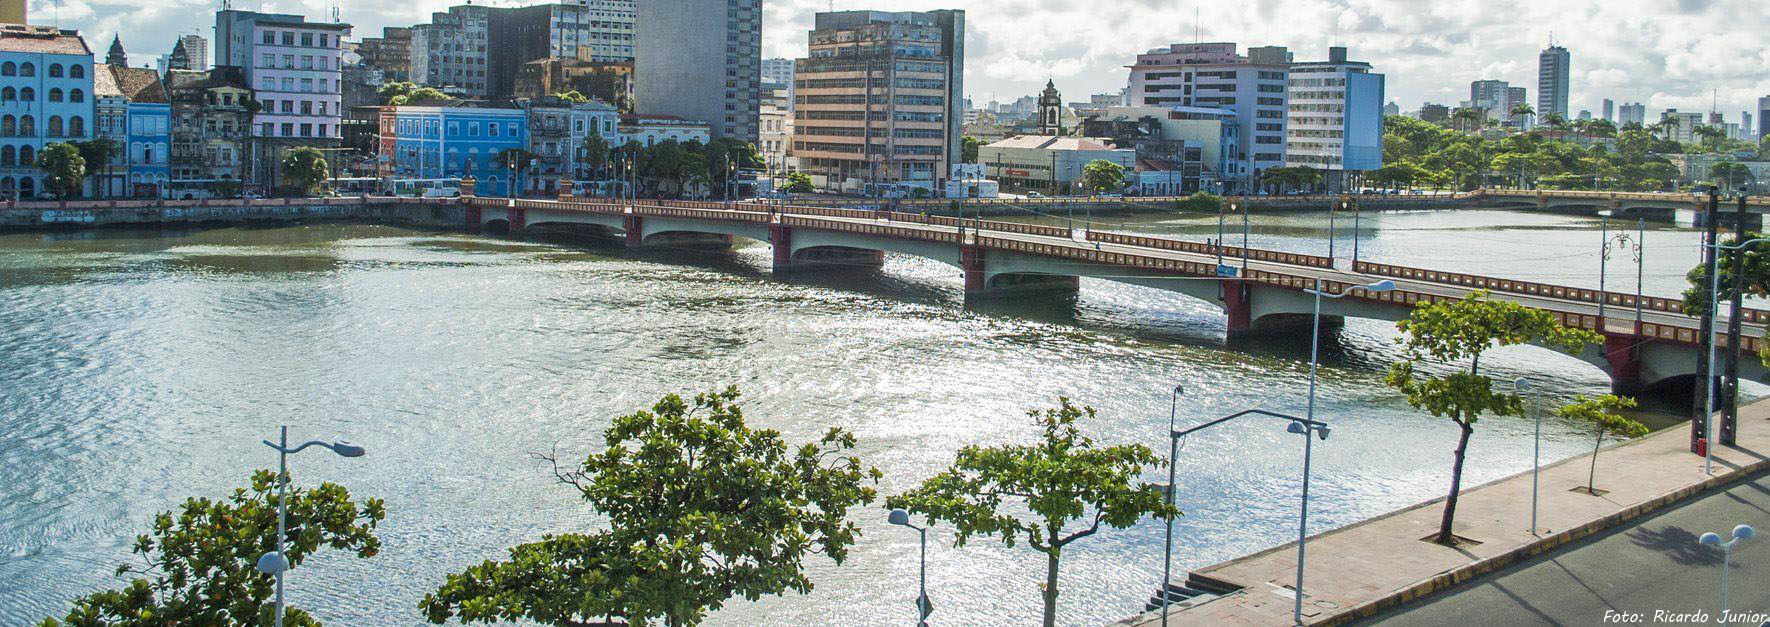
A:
[0,25,94,198]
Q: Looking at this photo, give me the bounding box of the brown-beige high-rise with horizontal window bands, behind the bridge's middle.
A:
[792,11,965,191]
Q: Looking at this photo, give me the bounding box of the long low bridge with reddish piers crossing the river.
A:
[462,188,1770,393]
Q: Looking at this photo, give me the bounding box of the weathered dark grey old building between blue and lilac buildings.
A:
[165,66,257,198]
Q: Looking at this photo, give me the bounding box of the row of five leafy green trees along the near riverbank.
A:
[42,286,1677,625]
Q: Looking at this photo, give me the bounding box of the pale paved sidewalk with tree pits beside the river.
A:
[1119,402,1770,627]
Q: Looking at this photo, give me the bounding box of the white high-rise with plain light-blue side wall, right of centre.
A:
[1285,46,1384,185]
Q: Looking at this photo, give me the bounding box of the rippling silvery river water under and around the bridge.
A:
[0,211,1741,625]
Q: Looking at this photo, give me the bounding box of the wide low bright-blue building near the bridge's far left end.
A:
[381,101,529,197]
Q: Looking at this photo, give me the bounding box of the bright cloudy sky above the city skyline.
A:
[30,0,1770,122]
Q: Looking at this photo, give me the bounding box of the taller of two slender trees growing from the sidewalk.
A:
[1384,290,1604,546]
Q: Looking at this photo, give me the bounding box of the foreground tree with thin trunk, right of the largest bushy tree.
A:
[885,399,1181,627]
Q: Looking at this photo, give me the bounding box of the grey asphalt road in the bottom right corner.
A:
[1370,473,1770,627]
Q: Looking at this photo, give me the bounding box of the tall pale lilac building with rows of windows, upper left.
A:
[216,9,350,188]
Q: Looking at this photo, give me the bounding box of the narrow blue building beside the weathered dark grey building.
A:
[89,66,172,198]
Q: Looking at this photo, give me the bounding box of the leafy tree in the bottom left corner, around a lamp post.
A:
[42,471,388,627]
